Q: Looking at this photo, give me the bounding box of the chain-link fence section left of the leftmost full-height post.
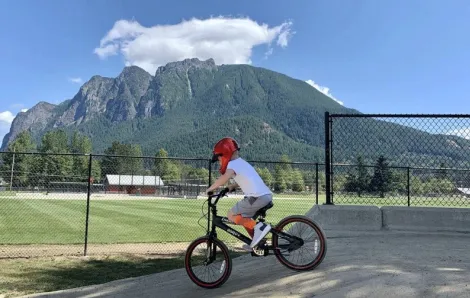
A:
[0,152,88,257]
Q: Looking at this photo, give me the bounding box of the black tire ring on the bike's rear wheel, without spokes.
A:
[272,215,327,271]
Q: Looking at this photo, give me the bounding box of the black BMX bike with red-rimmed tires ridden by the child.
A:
[184,189,327,289]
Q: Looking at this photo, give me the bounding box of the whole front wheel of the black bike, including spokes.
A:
[184,236,232,289]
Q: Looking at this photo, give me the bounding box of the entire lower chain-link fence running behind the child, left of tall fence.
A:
[0,152,325,258]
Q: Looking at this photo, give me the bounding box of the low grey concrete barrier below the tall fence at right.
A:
[306,205,470,233]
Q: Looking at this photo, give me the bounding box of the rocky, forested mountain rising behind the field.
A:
[2,59,470,168]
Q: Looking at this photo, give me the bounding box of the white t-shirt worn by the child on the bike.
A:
[227,157,271,197]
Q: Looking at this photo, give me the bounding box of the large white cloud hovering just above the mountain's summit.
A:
[94,17,294,74]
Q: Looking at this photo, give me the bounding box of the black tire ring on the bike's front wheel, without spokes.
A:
[184,236,232,289]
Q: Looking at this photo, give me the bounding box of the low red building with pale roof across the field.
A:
[104,175,164,195]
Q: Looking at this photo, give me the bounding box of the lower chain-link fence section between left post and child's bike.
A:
[87,155,209,254]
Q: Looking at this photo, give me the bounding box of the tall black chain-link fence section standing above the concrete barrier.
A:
[325,113,470,207]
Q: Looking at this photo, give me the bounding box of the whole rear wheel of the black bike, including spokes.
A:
[272,215,327,271]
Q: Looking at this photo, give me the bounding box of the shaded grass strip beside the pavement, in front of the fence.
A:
[0,251,246,297]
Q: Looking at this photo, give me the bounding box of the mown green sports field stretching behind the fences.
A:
[0,194,470,244]
